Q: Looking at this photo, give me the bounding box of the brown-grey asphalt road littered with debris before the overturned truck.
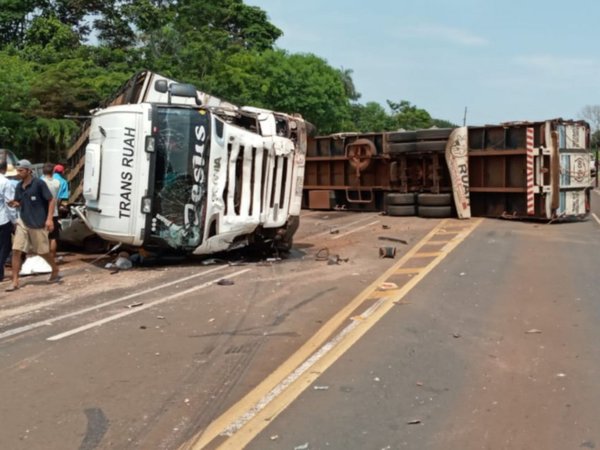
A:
[0,194,600,450]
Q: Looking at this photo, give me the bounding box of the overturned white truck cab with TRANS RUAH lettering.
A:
[79,77,306,255]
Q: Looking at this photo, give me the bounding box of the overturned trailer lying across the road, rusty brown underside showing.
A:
[303,119,592,220]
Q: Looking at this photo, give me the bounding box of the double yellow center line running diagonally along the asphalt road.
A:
[181,219,482,450]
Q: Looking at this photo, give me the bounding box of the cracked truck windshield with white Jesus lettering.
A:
[151,106,210,250]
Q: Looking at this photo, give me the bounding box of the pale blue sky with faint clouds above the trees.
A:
[245,0,600,125]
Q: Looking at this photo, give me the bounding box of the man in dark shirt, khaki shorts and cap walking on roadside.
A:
[6,159,60,292]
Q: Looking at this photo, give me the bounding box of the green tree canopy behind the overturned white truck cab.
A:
[0,0,452,161]
